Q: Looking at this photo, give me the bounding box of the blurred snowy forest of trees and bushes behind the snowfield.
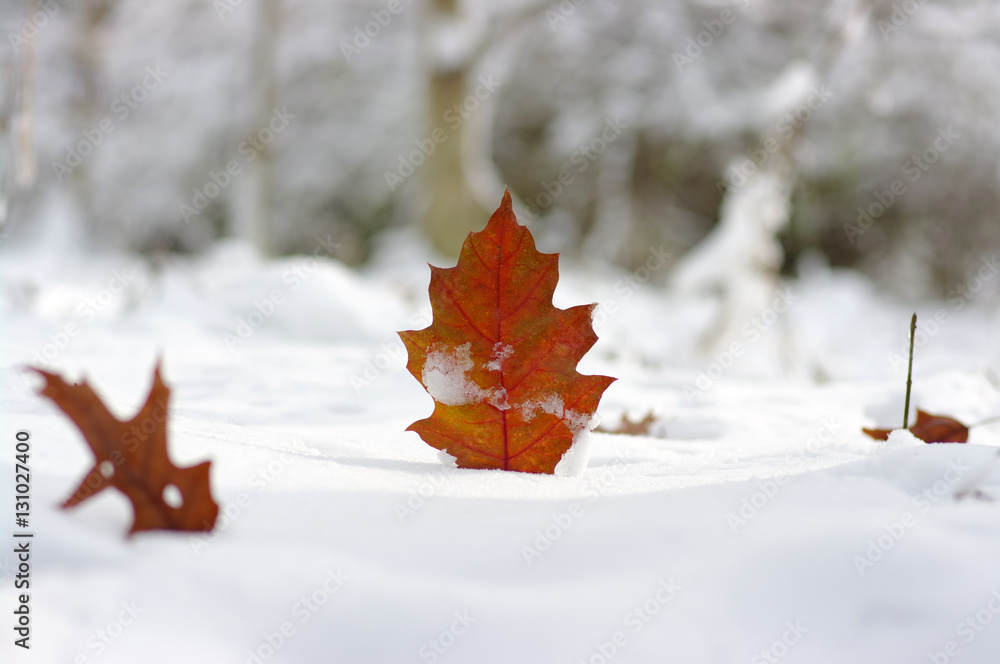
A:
[0,0,1000,297]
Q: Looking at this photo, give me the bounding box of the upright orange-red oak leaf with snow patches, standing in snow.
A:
[399,191,615,473]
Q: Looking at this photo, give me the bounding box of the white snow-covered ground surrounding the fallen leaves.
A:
[0,231,1000,664]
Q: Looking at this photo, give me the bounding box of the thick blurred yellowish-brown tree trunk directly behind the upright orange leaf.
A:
[422,0,487,256]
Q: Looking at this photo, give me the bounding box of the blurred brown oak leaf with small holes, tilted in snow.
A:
[32,363,219,535]
